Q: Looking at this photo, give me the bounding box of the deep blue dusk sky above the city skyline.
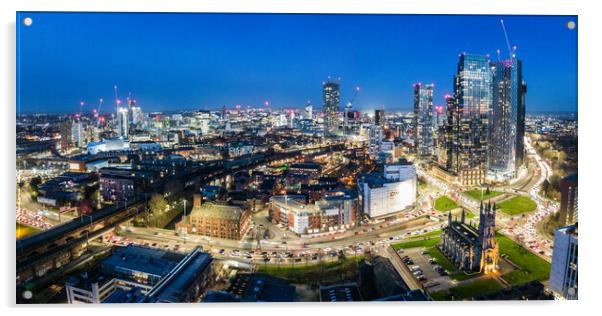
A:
[17,13,578,113]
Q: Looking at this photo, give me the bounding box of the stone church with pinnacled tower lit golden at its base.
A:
[439,202,499,273]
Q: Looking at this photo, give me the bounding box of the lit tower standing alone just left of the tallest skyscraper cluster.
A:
[414,83,435,158]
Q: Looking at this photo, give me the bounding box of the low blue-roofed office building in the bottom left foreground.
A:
[65,245,212,304]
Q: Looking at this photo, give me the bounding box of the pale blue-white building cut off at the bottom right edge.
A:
[550,223,578,300]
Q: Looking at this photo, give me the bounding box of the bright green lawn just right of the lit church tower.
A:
[496,234,551,285]
